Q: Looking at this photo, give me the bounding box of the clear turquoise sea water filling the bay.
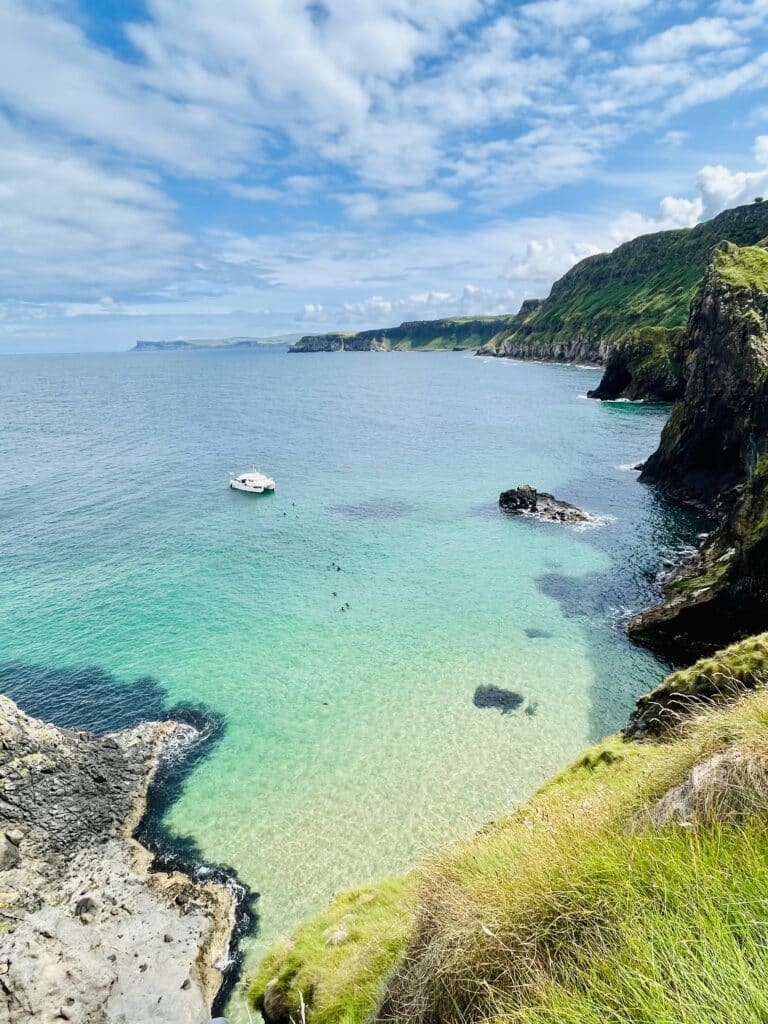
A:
[0,352,693,1019]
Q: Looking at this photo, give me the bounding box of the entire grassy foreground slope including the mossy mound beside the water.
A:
[252,655,768,1024]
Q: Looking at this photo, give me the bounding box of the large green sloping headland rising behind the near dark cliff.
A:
[485,203,768,372]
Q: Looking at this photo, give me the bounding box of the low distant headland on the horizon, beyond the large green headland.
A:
[291,316,507,352]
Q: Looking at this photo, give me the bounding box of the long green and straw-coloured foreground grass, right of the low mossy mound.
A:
[385,690,768,1024]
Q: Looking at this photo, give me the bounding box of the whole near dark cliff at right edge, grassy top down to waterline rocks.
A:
[630,244,768,658]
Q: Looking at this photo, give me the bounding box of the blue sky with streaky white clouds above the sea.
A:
[0,0,768,352]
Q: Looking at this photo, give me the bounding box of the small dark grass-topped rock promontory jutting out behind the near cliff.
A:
[587,328,686,401]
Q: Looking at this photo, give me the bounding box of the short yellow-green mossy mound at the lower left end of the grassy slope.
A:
[250,878,415,1024]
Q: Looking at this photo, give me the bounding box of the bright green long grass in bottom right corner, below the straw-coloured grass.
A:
[498,817,768,1024]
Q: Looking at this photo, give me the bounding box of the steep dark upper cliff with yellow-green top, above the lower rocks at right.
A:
[641,243,768,507]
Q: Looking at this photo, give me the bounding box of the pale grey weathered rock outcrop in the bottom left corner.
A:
[0,697,232,1024]
